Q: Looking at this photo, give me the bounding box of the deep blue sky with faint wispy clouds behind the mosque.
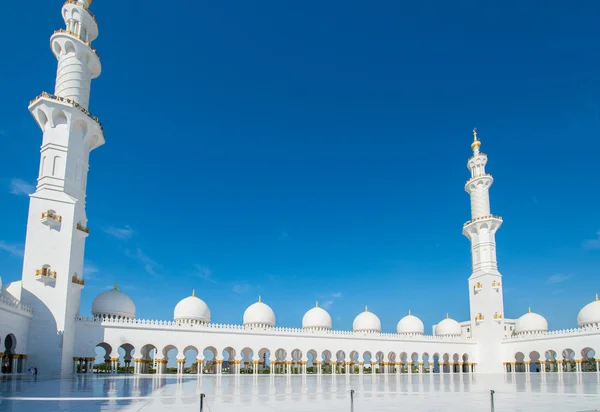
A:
[0,0,600,332]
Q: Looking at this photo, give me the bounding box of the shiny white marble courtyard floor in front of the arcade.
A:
[0,373,600,412]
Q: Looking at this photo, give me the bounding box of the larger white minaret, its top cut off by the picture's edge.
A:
[22,0,104,374]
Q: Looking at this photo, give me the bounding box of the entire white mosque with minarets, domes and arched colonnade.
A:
[0,0,600,375]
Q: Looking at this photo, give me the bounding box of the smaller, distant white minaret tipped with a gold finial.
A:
[463,129,504,372]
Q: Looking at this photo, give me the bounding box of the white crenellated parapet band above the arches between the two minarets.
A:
[75,316,473,342]
